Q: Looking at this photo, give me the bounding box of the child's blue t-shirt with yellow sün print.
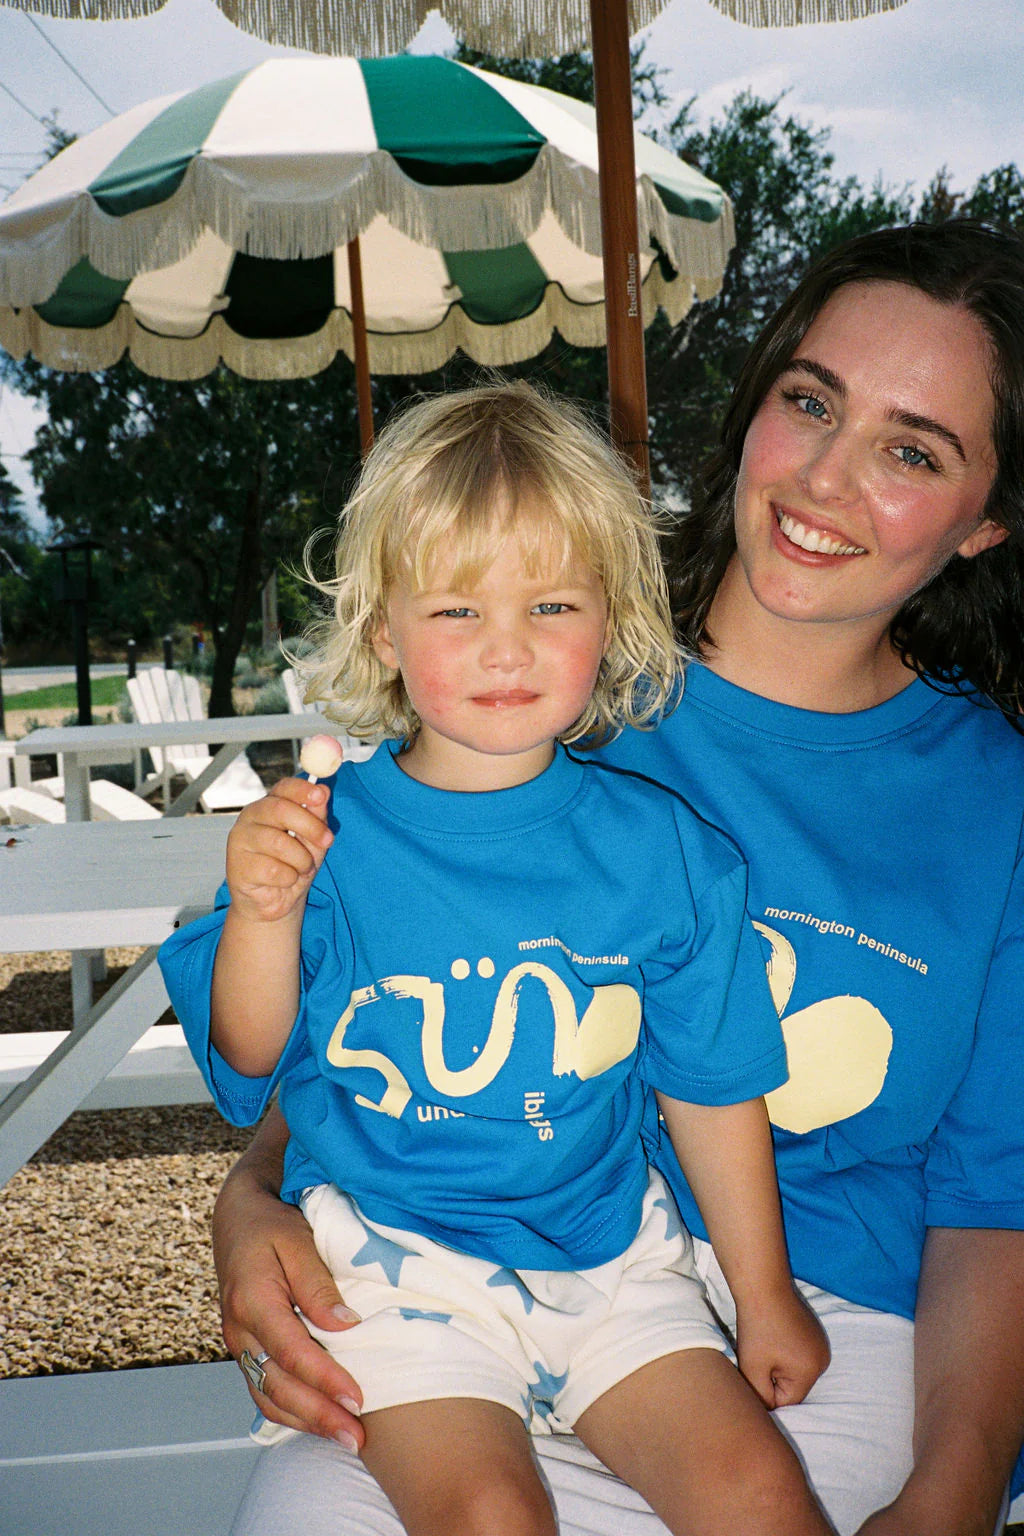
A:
[161,748,786,1269]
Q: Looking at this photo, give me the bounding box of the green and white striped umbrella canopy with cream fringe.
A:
[0,57,732,378]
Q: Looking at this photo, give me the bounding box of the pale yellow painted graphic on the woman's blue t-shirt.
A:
[754,923,892,1134]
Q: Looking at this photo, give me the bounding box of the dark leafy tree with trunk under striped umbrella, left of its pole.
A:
[11,359,373,714]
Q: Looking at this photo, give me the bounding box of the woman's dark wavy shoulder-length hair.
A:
[669,220,1024,728]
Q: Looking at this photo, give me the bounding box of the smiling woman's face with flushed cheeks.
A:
[726,283,1006,634]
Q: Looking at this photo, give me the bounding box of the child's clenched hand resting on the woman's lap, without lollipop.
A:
[735,1289,831,1409]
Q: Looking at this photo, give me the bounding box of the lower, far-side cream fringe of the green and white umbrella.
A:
[0,253,720,381]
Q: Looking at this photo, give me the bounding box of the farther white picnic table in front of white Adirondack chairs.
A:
[14,710,324,822]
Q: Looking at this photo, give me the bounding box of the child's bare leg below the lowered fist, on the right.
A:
[574,1349,831,1536]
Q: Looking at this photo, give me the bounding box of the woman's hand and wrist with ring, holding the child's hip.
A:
[213,1107,364,1448]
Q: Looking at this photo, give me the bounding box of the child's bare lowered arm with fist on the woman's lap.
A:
[657,1094,829,1409]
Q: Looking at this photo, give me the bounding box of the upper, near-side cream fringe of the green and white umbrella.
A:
[0,146,734,309]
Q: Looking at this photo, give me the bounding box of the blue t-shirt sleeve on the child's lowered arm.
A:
[639,829,788,1104]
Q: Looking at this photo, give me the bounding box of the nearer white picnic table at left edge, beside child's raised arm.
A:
[0,817,235,1186]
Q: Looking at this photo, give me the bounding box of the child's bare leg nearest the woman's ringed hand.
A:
[362,1398,556,1536]
